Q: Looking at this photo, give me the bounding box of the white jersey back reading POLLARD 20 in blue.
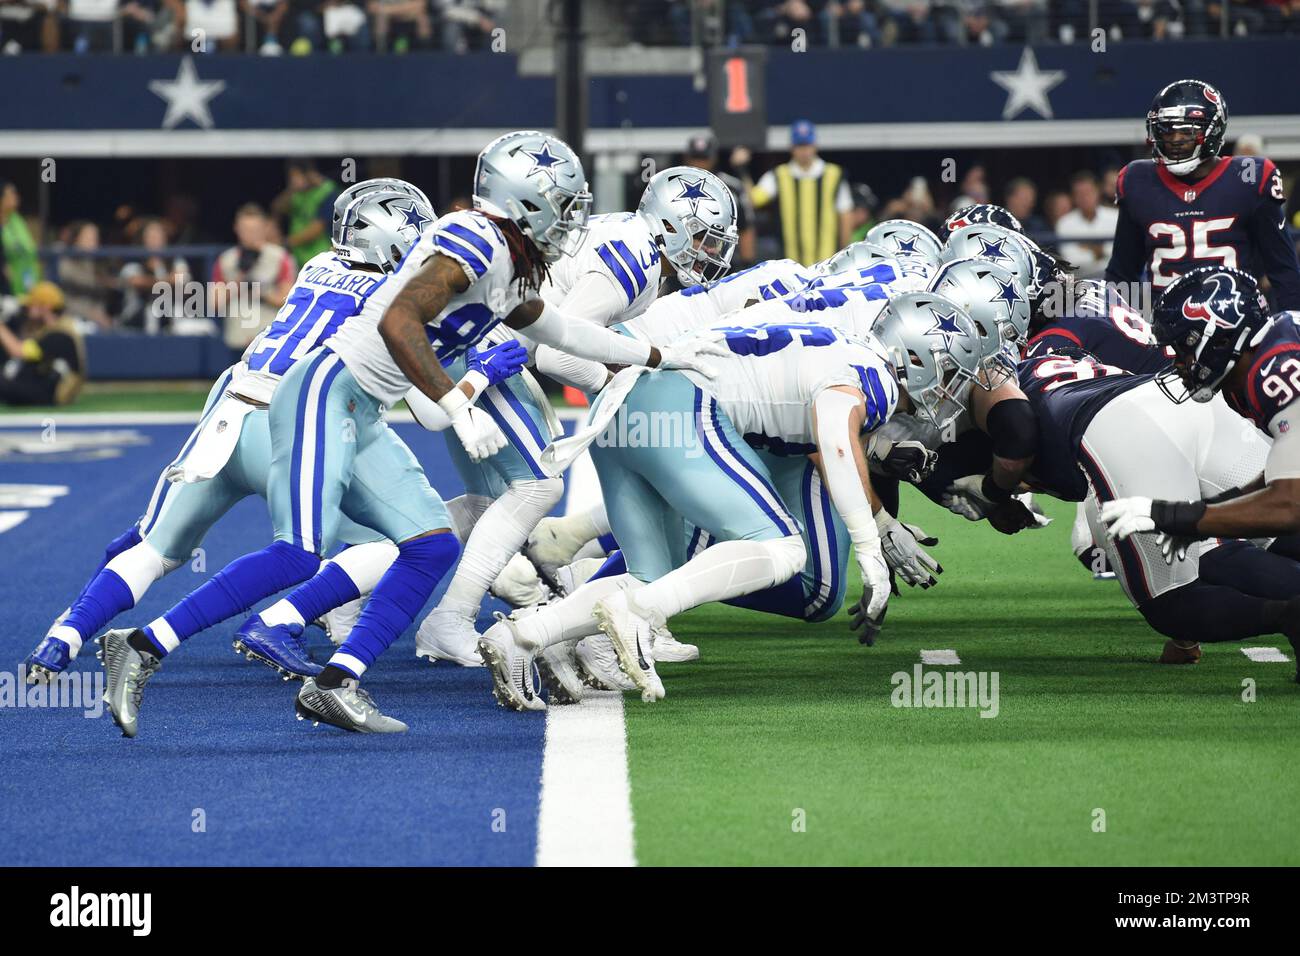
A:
[241,252,386,403]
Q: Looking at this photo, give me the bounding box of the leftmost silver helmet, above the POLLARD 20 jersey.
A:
[333,183,437,272]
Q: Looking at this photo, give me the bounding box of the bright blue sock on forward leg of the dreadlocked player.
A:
[335,532,460,676]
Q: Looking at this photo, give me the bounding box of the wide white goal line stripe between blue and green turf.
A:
[537,691,637,866]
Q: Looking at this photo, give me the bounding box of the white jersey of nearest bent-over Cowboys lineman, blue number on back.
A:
[683,321,898,454]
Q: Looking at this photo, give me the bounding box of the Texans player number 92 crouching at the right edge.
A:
[1101,267,1300,680]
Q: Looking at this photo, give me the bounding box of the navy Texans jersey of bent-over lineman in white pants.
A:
[1017,354,1152,501]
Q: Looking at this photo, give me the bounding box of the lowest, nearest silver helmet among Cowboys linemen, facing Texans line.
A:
[871,293,983,431]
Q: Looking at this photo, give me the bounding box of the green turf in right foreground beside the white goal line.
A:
[625,496,1300,865]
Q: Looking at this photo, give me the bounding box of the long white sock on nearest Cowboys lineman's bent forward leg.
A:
[628,535,806,624]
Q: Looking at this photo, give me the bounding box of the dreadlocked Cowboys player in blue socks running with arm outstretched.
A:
[103,131,719,735]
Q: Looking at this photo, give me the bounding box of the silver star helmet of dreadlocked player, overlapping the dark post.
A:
[475,130,592,263]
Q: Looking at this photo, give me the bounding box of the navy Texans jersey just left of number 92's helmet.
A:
[1024,280,1170,375]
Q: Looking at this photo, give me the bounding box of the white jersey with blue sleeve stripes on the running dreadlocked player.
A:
[325,209,524,407]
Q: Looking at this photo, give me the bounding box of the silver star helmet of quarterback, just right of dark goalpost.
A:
[637,166,738,287]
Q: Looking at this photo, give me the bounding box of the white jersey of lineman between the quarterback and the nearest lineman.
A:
[624,259,811,343]
